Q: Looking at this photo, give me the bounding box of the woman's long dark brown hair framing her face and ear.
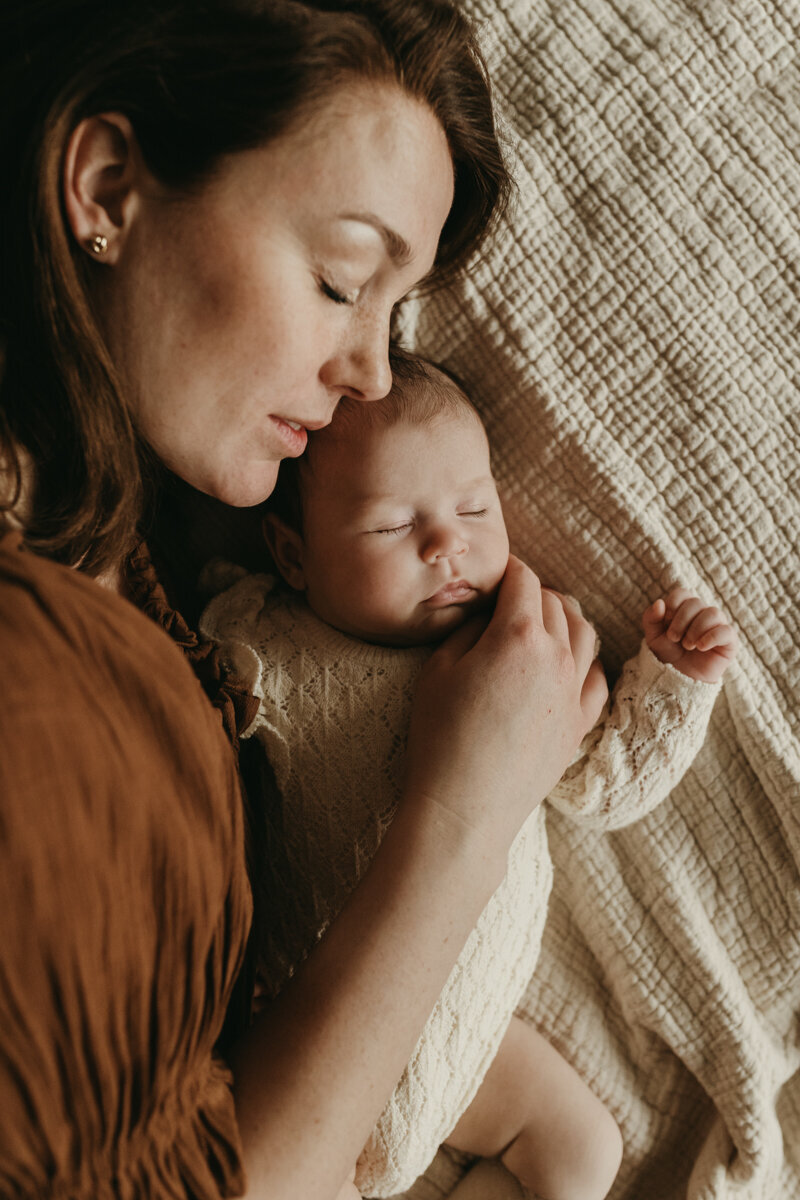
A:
[0,0,509,572]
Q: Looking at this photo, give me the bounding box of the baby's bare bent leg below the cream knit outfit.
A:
[447,1018,622,1200]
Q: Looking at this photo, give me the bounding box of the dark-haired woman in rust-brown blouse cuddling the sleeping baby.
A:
[0,0,604,1200]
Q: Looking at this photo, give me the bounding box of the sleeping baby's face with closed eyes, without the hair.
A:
[297,409,509,646]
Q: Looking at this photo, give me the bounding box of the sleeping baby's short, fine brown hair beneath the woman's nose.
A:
[268,346,483,533]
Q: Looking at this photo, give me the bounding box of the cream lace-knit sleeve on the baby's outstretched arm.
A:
[547,642,721,829]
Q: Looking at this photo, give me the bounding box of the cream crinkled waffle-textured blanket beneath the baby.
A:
[393,0,800,1200]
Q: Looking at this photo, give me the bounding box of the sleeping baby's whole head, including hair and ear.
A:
[264,353,509,646]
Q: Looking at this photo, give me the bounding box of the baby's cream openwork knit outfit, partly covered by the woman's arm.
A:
[200,576,718,1196]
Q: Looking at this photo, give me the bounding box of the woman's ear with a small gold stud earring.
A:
[64,113,146,263]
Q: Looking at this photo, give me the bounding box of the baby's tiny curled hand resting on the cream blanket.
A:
[642,588,739,683]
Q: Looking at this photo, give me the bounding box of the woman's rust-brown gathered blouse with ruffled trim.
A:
[0,533,256,1200]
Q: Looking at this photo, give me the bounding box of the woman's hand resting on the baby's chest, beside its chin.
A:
[405,557,608,851]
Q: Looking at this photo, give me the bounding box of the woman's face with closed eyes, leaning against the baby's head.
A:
[97,84,453,505]
